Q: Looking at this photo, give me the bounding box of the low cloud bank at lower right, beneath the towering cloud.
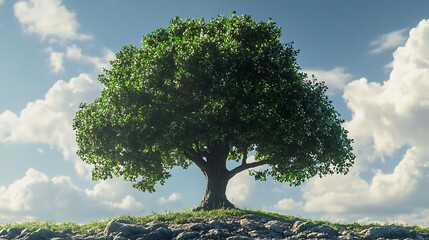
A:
[303,148,429,225]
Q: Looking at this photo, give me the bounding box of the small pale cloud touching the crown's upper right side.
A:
[303,67,352,95]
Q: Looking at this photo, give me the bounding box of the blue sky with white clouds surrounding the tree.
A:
[0,0,429,226]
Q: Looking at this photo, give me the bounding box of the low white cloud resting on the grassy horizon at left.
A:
[0,169,143,222]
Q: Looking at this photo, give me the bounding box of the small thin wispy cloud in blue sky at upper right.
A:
[369,28,407,54]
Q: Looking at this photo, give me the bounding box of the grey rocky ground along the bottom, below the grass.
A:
[0,216,429,240]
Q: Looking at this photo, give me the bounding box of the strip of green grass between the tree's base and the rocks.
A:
[0,209,429,234]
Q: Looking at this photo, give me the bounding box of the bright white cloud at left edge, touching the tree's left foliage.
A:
[0,74,101,175]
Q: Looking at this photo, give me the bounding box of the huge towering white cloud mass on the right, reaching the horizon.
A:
[290,20,429,225]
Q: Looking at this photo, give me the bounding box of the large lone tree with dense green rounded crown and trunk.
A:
[73,12,355,209]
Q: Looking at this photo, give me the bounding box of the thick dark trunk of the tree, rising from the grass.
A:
[195,162,235,211]
